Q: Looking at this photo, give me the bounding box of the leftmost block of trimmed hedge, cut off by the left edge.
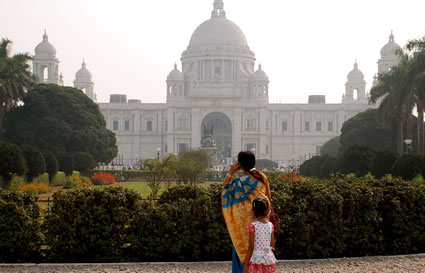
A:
[0,190,41,263]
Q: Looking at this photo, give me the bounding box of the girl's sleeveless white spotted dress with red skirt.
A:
[248,221,276,273]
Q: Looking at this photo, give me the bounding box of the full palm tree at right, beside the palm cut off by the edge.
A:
[369,52,415,154]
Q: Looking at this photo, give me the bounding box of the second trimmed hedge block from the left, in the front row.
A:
[43,187,140,262]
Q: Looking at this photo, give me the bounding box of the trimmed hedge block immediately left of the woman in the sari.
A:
[130,186,231,261]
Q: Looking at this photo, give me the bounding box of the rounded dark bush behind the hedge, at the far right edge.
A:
[391,154,423,180]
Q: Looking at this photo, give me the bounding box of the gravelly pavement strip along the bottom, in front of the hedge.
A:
[0,254,425,273]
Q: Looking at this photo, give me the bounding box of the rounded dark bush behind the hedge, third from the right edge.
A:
[342,145,375,176]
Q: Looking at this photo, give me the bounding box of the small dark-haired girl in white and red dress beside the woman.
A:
[243,197,276,273]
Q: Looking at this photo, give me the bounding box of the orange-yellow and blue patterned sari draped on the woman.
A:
[221,176,270,272]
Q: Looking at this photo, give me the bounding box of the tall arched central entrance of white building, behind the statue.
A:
[201,112,232,163]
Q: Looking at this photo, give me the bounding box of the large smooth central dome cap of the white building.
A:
[189,17,248,47]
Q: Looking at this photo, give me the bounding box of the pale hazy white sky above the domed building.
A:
[0,0,425,103]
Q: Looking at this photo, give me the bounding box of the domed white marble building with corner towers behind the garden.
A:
[33,0,400,167]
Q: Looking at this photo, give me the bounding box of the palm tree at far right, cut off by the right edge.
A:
[405,36,425,154]
